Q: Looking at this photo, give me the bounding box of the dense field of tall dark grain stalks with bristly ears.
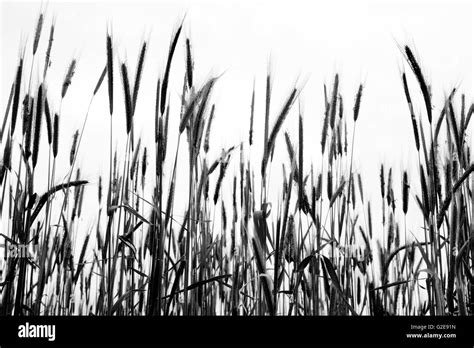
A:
[0,6,474,316]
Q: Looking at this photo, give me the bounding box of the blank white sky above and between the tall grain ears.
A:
[0,0,474,245]
